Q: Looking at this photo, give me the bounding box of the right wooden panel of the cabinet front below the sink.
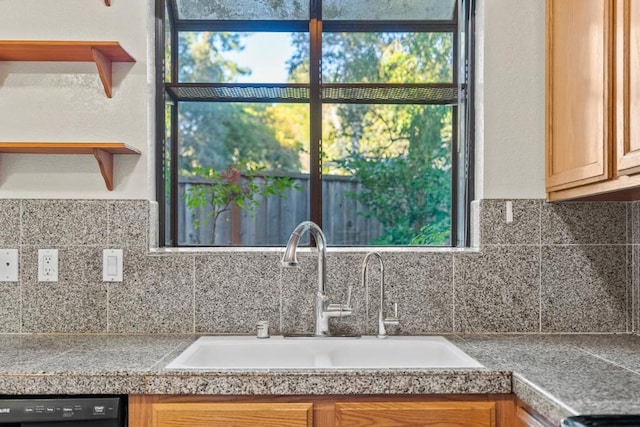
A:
[335,402,496,427]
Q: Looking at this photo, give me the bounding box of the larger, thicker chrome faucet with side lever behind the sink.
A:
[282,221,353,337]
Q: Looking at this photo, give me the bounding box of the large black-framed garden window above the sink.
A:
[157,0,473,246]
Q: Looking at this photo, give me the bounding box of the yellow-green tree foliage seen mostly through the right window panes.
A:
[290,33,453,245]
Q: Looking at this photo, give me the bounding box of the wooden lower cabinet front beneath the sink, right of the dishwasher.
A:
[129,394,526,427]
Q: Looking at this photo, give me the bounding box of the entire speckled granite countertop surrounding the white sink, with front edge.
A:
[0,335,640,423]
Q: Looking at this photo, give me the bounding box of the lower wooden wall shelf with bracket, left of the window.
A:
[0,142,140,191]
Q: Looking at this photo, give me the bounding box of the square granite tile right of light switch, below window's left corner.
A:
[109,248,194,333]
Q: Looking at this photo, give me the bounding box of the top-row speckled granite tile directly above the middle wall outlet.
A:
[21,200,109,248]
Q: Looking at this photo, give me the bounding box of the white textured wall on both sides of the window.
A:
[0,0,544,199]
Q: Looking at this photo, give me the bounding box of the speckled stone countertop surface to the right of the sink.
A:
[453,334,640,423]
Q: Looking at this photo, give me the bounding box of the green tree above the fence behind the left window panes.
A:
[178,32,300,176]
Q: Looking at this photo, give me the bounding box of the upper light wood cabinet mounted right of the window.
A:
[546,0,640,200]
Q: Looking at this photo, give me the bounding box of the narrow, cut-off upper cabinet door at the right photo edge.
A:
[616,0,640,175]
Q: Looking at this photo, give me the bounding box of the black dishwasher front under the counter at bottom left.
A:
[0,396,127,427]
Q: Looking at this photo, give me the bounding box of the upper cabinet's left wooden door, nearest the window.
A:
[544,0,614,190]
